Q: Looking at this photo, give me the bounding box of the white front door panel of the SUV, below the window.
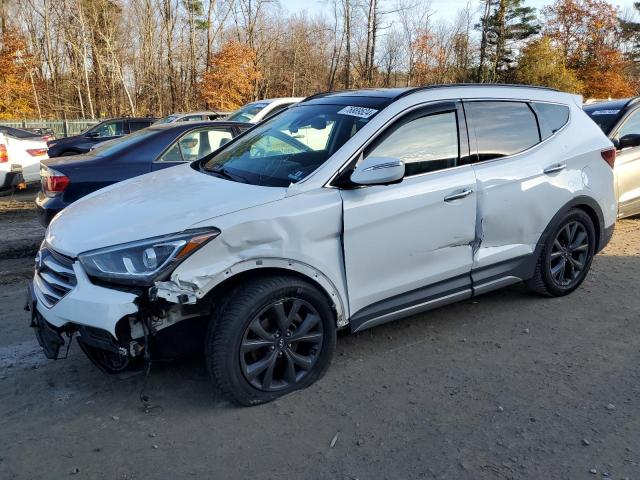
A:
[341,165,476,314]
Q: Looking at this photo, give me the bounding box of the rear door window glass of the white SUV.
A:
[465,101,540,161]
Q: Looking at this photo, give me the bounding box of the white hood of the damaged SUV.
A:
[46,165,287,256]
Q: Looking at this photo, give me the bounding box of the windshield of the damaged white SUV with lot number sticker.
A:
[202,104,378,187]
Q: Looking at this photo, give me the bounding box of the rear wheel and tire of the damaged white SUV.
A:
[528,209,596,297]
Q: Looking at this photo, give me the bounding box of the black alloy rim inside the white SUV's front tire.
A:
[240,298,324,392]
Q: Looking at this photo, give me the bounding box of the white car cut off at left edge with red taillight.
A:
[0,126,49,185]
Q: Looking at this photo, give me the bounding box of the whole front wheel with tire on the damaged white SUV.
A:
[205,276,336,406]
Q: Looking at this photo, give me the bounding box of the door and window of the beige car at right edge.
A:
[613,109,640,216]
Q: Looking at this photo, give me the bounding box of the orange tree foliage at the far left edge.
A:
[0,29,35,119]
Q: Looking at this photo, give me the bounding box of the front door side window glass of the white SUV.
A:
[366,112,458,176]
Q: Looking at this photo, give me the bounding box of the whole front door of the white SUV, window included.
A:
[341,102,476,330]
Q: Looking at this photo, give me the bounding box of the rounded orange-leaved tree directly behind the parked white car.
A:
[200,41,260,111]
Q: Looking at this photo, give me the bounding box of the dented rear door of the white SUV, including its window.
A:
[464,100,582,285]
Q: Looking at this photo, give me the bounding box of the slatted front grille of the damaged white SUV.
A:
[34,247,76,308]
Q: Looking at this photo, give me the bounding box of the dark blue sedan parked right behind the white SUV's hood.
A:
[36,122,252,226]
